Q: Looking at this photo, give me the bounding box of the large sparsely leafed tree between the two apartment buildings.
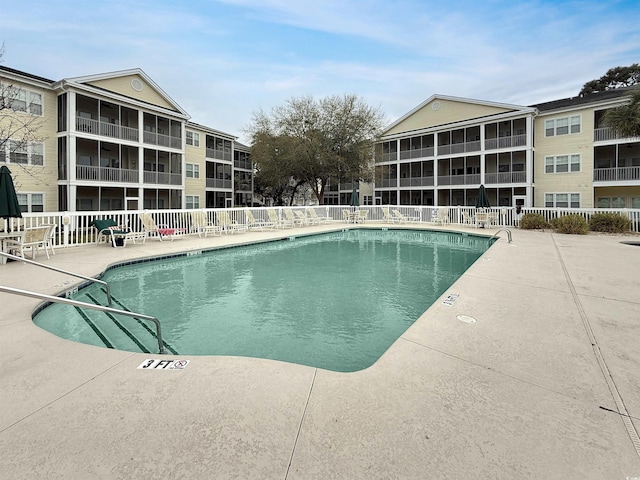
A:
[246,95,384,203]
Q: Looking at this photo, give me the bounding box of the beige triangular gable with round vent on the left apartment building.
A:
[54,68,189,119]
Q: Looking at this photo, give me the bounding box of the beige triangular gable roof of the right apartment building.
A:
[383,94,536,136]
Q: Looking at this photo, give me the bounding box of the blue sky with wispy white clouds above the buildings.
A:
[0,0,640,141]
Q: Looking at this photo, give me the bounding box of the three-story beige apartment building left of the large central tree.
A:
[0,66,253,212]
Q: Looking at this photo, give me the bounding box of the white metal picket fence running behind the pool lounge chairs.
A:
[0,205,640,247]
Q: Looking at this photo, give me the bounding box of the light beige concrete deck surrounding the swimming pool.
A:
[0,224,640,480]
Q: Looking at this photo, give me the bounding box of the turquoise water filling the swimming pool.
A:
[34,229,492,372]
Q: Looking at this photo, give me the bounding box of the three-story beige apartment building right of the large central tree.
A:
[374,89,640,208]
